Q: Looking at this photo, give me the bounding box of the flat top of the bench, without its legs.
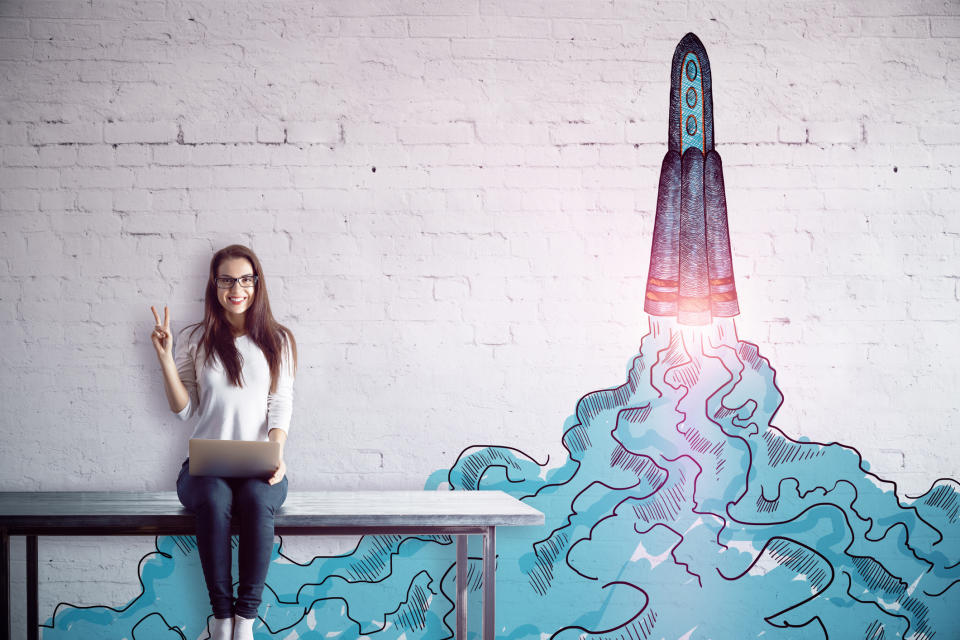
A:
[0,491,544,535]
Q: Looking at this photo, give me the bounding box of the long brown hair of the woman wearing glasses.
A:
[188,244,297,393]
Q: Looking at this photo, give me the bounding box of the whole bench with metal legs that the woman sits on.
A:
[0,491,544,640]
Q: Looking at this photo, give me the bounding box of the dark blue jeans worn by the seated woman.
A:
[177,458,288,618]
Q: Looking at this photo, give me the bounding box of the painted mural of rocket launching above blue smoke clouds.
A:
[43,34,960,640]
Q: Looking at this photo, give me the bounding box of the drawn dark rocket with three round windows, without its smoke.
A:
[643,33,740,325]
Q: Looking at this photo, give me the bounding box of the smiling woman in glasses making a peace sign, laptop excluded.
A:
[151,245,297,640]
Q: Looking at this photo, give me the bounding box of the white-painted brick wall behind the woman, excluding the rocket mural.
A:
[0,0,960,628]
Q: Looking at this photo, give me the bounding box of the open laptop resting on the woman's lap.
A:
[190,438,280,478]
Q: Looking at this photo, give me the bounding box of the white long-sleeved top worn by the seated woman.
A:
[174,331,293,456]
